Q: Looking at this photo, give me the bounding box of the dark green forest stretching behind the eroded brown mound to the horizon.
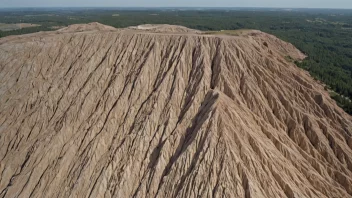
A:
[0,8,352,114]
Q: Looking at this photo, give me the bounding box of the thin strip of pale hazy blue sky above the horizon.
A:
[0,0,352,9]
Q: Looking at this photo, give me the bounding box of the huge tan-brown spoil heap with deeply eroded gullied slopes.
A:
[0,24,352,198]
